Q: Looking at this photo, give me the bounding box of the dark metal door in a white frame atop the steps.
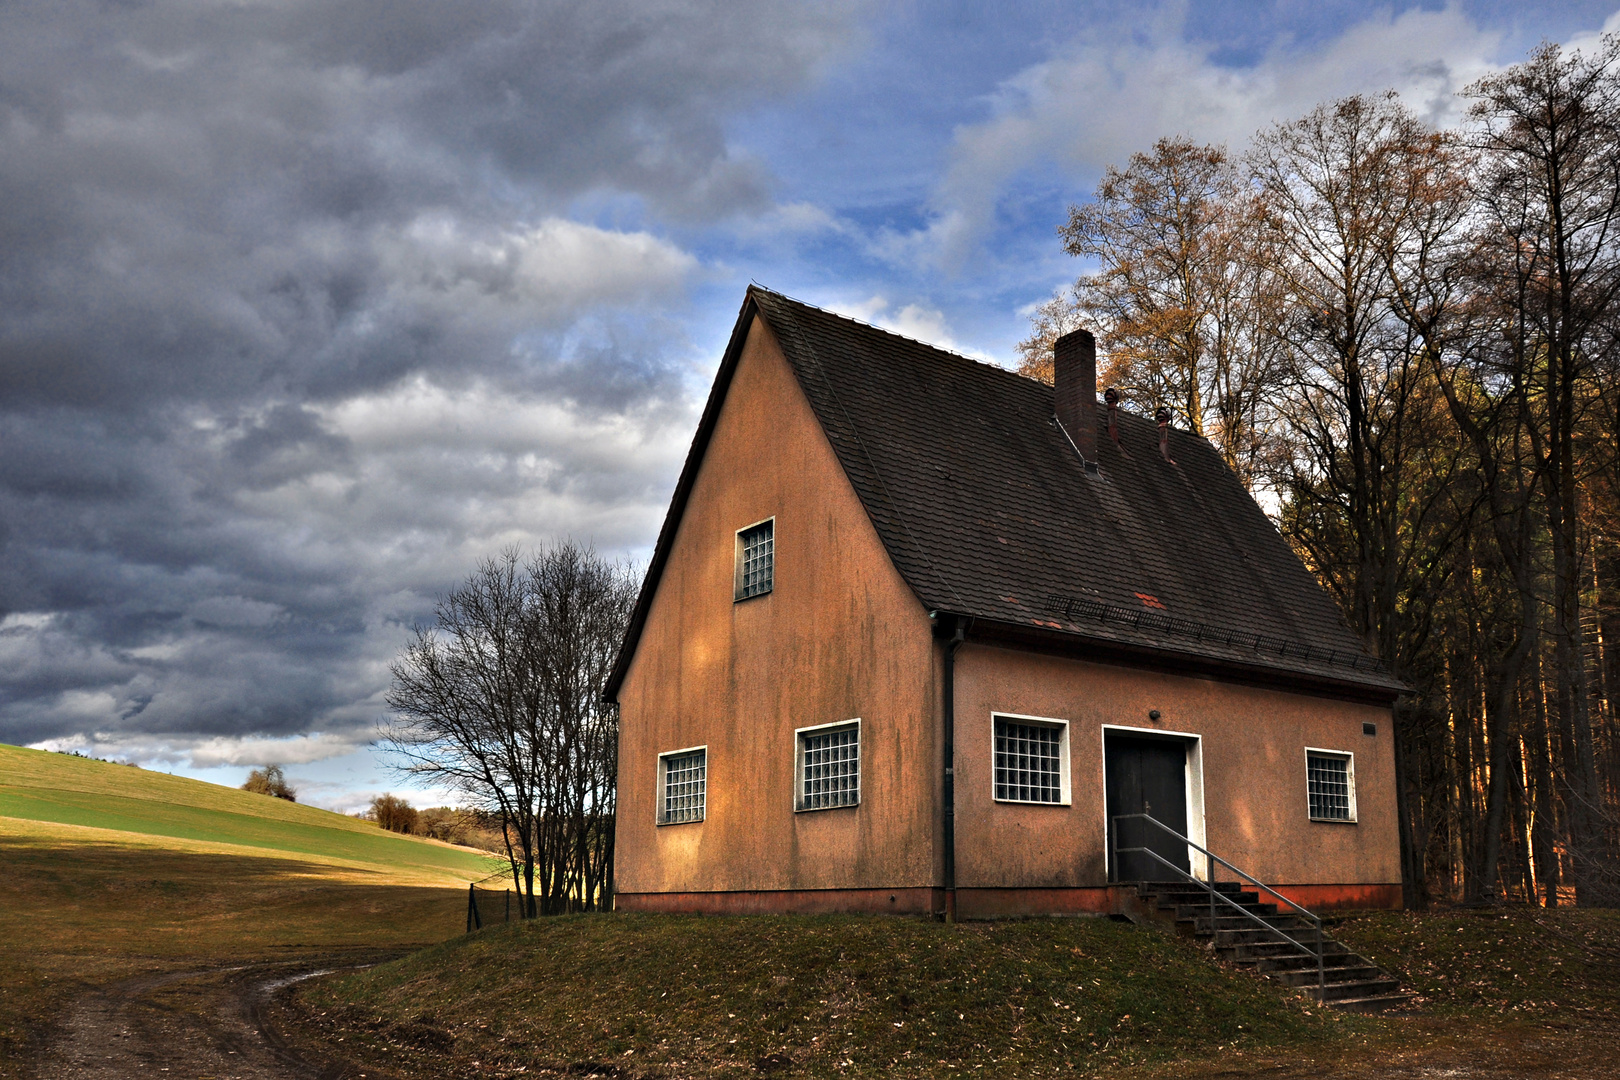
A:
[1105,733,1189,881]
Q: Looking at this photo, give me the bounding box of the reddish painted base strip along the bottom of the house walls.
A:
[614,884,1401,918]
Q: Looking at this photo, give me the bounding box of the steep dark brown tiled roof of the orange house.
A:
[612,287,1401,696]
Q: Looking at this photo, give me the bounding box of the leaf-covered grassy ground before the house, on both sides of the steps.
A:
[295,908,1620,1080]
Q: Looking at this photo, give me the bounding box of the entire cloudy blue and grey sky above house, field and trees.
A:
[0,0,1620,810]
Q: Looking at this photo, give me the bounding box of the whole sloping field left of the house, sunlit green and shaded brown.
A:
[0,745,496,1078]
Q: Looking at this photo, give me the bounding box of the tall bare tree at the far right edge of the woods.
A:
[1468,37,1620,904]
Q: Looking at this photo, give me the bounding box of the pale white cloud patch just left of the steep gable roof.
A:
[285,377,692,566]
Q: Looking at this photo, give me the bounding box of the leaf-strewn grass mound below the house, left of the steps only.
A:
[305,915,1347,1077]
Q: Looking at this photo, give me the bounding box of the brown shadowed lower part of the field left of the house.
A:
[0,836,467,1078]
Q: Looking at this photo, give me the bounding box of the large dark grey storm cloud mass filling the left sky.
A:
[0,0,847,759]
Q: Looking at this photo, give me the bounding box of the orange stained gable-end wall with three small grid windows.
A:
[617,319,938,894]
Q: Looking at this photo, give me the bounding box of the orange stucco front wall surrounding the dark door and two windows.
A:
[956,644,1400,889]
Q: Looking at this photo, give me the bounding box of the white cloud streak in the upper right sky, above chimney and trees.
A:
[873,6,1502,267]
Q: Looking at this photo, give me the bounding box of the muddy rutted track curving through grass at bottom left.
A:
[37,952,396,1080]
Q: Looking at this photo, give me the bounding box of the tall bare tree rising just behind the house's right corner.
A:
[1251,94,1466,904]
